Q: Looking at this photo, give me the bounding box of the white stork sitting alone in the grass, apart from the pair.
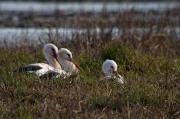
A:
[102,59,124,84]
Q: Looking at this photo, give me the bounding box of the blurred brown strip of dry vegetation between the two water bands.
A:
[0,7,180,29]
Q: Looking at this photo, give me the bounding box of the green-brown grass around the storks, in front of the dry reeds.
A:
[0,36,180,119]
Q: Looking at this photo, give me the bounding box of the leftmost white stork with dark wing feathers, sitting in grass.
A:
[18,43,68,77]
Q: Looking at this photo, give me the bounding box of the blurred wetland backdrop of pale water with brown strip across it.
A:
[0,0,180,44]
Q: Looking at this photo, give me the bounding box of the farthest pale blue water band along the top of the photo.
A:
[0,2,180,12]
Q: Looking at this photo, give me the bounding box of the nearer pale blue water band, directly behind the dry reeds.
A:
[0,27,180,44]
